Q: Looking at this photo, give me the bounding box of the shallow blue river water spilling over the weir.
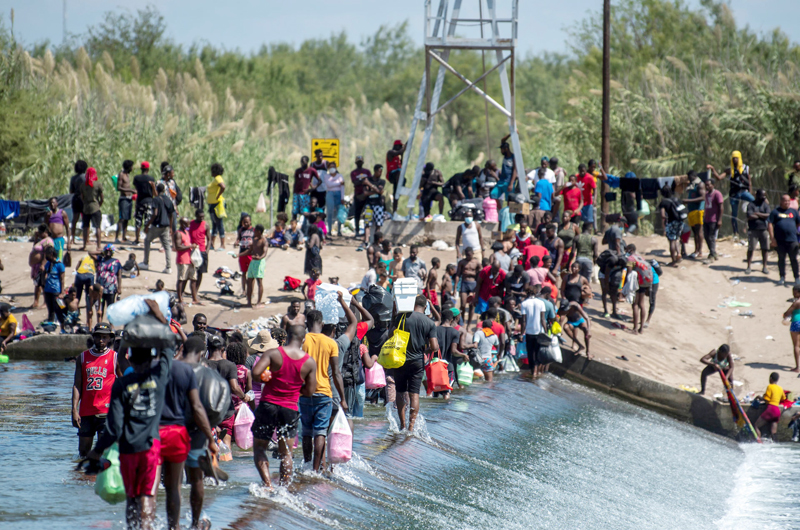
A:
[0,361,800,530]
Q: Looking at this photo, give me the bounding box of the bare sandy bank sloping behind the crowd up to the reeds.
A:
[0,225,797,397]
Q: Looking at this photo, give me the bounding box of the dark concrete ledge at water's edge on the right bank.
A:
[551,350,792,441]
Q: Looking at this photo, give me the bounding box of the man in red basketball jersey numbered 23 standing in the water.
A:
[72,322,122,458]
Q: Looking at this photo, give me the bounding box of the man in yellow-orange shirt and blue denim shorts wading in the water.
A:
[300,309,347,473]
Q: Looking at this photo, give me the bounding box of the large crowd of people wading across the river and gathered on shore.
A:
[12,137,800,528]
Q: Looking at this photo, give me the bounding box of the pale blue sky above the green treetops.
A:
[0,0,800,55]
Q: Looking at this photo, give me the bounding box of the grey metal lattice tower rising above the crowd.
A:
[396,0,528,212]
